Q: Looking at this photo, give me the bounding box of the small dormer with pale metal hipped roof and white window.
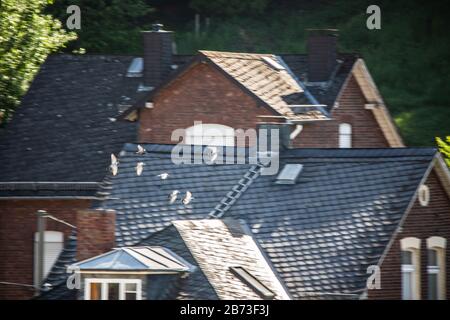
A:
[69,247,195,300]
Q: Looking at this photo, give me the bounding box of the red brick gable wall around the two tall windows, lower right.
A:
[368,171,450,299]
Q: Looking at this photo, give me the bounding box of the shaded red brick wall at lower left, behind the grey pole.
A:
[0,200,91,299]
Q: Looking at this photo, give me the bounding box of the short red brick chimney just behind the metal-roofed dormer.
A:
[76,209,116,261]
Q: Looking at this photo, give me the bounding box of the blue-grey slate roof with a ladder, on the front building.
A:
[37,144,436,299]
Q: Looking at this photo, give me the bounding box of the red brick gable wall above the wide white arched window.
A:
[138,63,273,144]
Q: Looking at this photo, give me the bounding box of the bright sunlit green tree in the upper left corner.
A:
[0,0,75,123]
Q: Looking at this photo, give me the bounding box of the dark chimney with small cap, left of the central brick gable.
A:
[142,24,173,87]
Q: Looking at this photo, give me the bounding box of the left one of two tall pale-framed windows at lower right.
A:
[400,237,421,300]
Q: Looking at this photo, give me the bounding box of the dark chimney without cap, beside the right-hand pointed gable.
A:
[307,29,338,82]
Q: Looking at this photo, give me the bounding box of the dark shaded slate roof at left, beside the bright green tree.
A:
[0,54,141,196]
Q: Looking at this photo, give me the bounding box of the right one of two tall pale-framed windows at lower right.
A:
[427,236,447,300]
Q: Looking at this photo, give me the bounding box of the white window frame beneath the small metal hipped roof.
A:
[84,278,142,300]
